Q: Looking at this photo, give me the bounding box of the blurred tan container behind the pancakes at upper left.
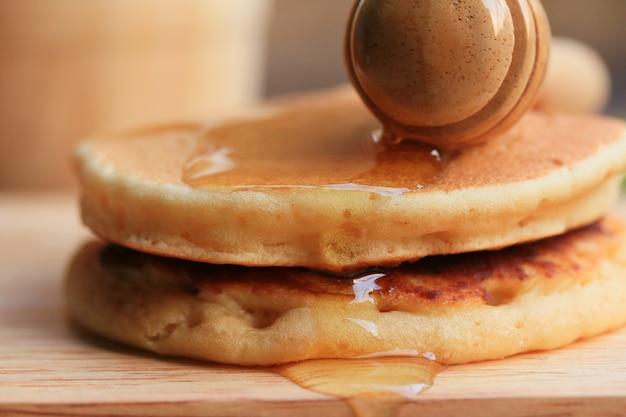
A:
[0,0,271,188]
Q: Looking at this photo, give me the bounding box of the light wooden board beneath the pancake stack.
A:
[0,194,626,417]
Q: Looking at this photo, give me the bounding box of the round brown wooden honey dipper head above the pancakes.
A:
[345,0,550,147]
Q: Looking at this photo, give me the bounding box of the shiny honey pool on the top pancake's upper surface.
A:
[182,93,443,195]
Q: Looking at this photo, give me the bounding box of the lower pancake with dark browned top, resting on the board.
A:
[66,216,626,365]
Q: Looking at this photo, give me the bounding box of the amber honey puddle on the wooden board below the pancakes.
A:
[270,356,445,417]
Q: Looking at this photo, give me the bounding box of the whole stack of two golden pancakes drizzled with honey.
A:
[67,88,626,365]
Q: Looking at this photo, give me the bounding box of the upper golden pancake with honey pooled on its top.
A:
[77,89,626,271]
